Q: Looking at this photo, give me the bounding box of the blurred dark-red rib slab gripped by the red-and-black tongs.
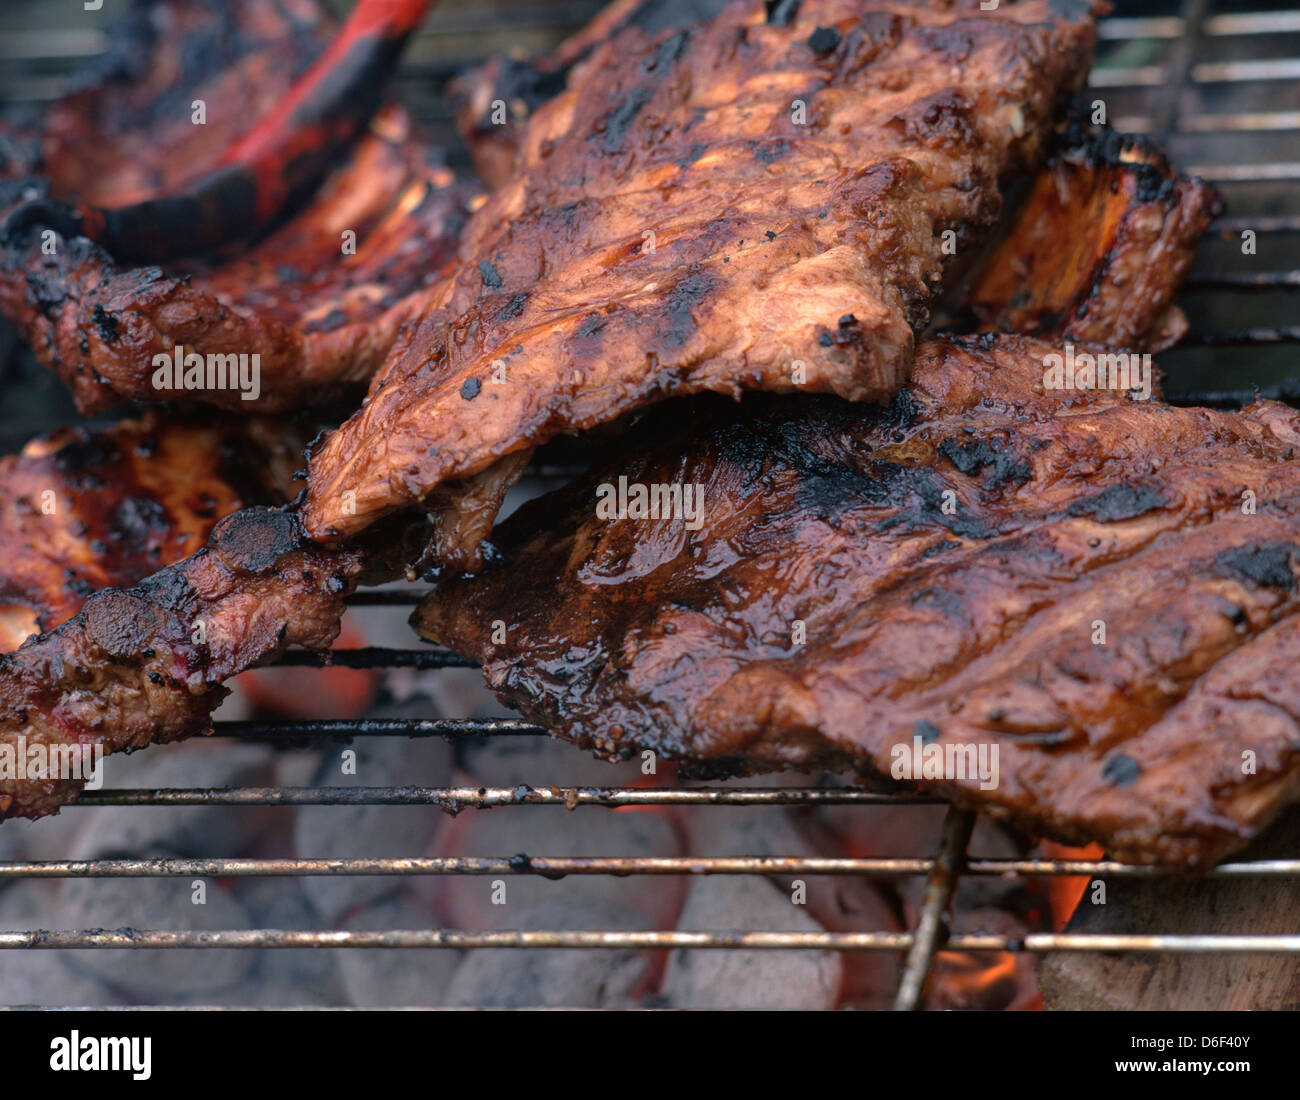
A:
[0,0,477,413]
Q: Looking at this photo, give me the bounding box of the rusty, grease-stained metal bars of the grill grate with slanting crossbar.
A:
[0,0,1300,1010]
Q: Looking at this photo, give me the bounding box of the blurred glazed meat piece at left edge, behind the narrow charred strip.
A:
[0,412,306,653]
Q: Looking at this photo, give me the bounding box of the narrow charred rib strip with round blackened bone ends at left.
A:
[0,508,404,819]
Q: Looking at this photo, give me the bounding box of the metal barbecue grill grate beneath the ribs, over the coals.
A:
[0,0,1300,1009]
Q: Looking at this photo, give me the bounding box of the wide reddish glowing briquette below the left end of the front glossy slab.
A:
[433,806,684,928]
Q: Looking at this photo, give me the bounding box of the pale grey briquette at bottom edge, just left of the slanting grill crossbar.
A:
[663,875,844,1009]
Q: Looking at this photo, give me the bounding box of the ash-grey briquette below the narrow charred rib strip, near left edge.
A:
[64,741,274,859]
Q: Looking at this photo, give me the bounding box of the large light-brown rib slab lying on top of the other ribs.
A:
[304,0,1095,540]
